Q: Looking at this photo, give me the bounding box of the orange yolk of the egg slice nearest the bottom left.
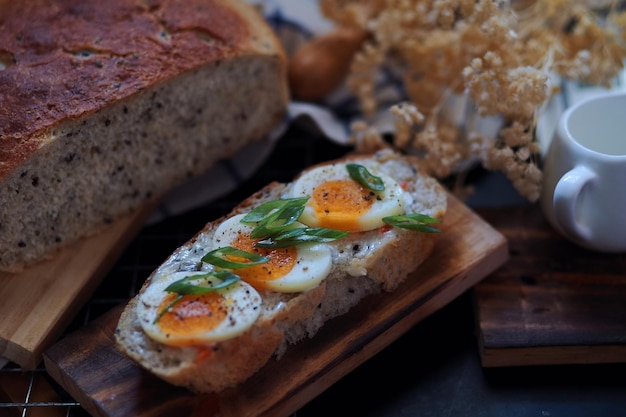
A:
[158,291,228,345]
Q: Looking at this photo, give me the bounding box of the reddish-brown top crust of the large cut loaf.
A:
[0,0,281,179]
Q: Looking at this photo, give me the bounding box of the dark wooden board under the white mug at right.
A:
[474,204,626,367]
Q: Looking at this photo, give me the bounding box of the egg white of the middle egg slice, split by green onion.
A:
[214,214,332,292]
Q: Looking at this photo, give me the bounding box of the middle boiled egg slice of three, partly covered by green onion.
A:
[213,214,332,292]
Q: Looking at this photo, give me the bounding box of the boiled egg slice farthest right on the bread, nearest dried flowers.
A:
[289,163,405,232]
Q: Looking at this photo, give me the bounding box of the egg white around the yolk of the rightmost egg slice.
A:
[289,163,406,231]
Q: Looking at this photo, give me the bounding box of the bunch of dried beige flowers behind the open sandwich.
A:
[320,0,626,201]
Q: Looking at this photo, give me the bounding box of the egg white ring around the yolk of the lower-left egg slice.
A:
[137,271,261,346]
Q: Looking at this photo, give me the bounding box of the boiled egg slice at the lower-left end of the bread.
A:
[137,271,261,346]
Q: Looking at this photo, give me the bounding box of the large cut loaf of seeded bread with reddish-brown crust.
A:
[0,0,288,271]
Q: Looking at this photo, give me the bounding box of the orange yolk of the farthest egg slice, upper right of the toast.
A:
[309,180,376,231]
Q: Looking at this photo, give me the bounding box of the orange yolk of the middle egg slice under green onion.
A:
[232,233,298,290]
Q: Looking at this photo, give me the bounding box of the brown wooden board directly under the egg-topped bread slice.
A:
[44,196,508,417]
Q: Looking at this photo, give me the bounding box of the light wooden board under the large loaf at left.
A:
[0,205,155,370]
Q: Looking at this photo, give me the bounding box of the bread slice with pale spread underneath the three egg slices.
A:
[115,150,446,393]
